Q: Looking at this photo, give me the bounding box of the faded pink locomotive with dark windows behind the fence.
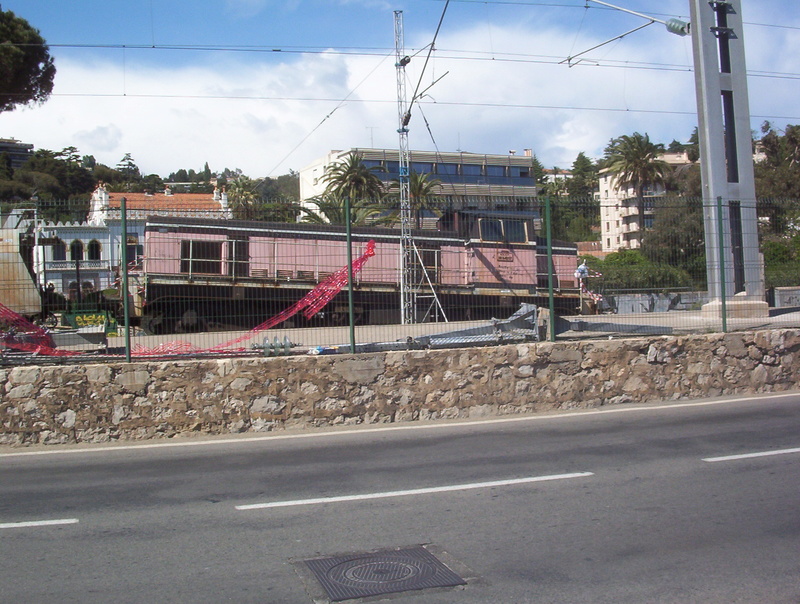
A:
[139,210,578,333]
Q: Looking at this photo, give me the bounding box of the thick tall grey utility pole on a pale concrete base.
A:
[690,0,768,317]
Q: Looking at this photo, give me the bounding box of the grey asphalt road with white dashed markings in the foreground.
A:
[0,394,800,604]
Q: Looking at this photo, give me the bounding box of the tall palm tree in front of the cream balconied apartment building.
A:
[606,132,669,240]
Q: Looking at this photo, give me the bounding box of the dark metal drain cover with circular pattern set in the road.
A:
[305,546,467,602]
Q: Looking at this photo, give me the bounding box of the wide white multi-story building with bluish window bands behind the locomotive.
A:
[300,148,556,210]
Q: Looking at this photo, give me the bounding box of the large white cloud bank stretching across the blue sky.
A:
[0,10,800,177]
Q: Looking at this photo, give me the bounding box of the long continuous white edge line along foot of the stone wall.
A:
[0,392,800,459]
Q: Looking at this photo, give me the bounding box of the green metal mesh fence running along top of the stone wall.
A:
[0,194,800,364]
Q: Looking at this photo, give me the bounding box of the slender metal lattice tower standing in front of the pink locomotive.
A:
[394,10,414,325]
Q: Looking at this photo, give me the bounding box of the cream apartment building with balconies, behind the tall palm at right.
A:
[599,153,692,253]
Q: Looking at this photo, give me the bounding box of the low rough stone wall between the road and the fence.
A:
[0,329,800,445]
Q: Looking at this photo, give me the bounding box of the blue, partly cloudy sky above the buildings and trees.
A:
[0,0,800,178]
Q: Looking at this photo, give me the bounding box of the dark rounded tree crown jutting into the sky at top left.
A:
[0,9,56,112]
